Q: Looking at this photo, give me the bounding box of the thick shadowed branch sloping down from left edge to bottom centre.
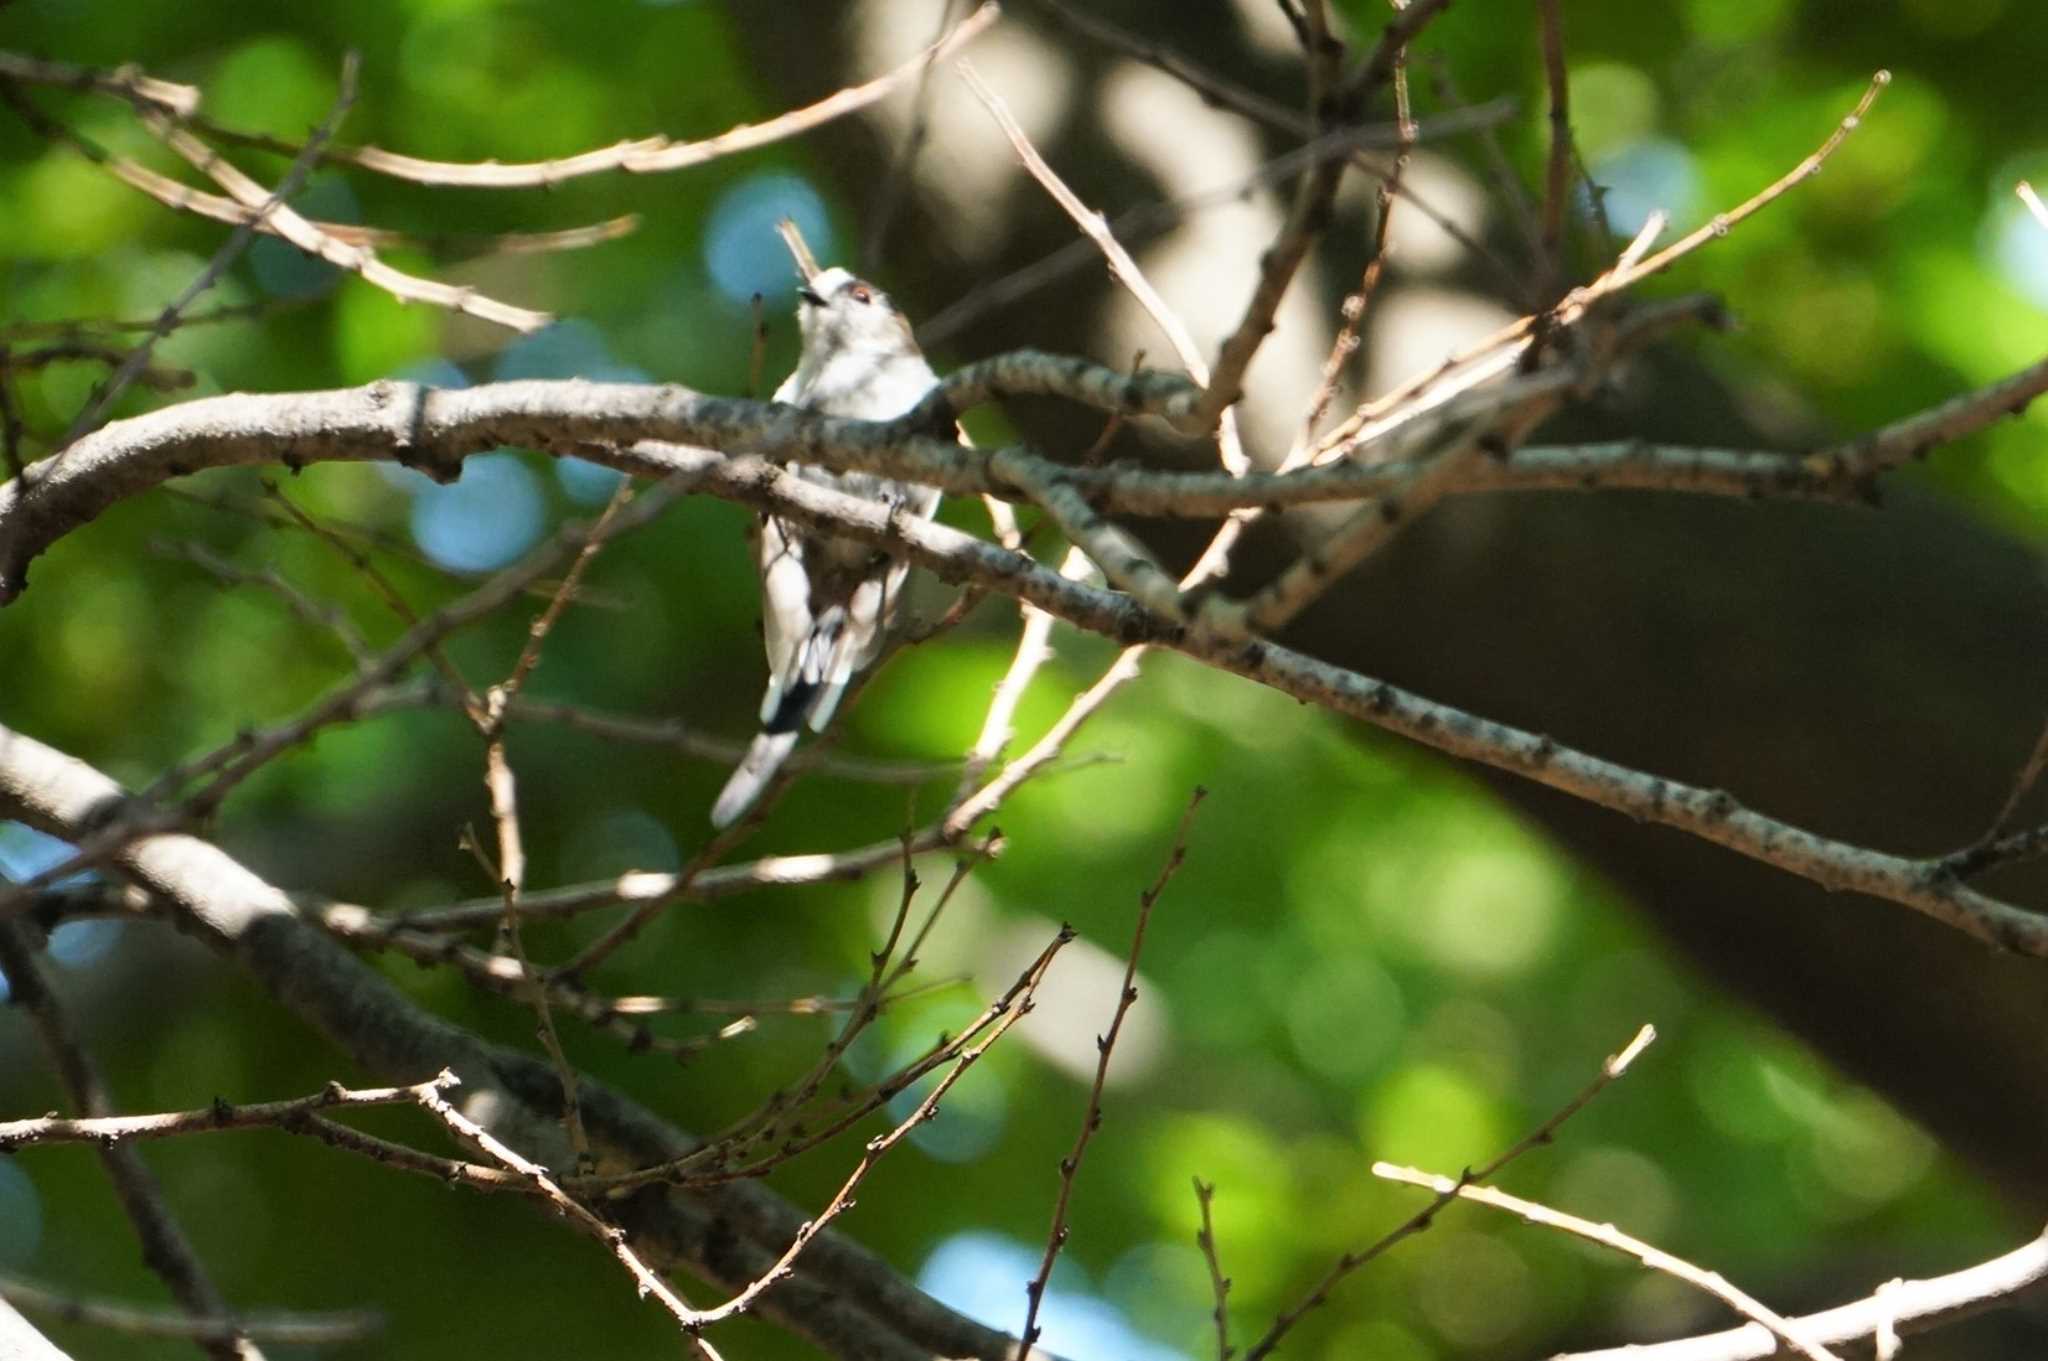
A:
[0,727,1064,1361]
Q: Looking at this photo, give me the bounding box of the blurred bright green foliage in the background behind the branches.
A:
[0,0,2048,1359]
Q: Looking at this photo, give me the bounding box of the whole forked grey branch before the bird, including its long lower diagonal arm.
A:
[12,354,2048,956]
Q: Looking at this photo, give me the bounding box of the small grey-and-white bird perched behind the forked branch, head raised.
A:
[711,268,938,827]
